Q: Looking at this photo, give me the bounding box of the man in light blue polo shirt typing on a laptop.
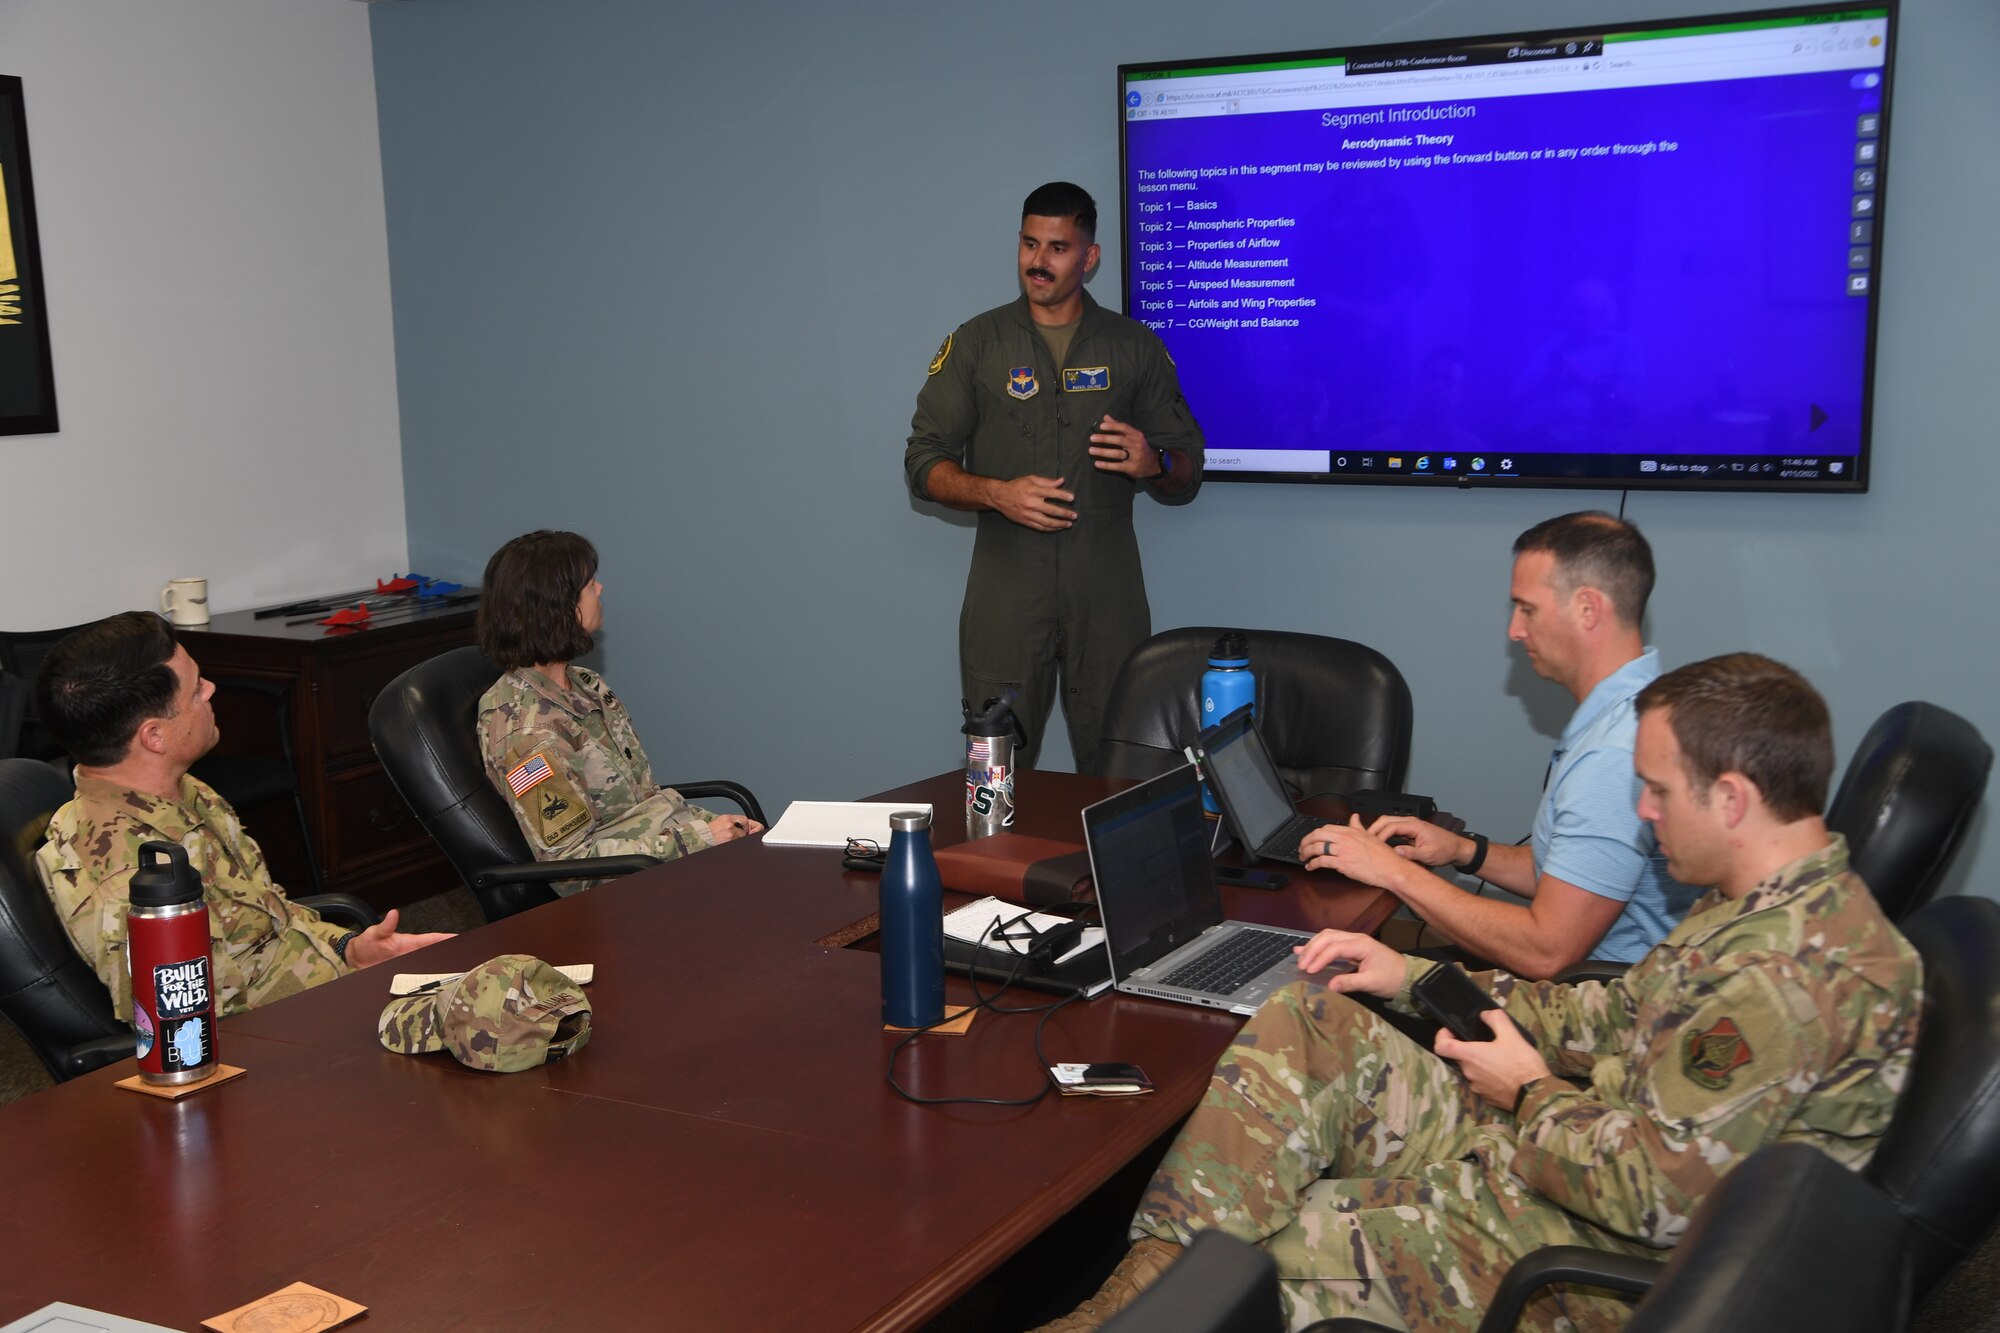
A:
[1300,510,1700,977]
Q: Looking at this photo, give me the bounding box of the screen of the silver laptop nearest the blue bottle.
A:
[1084,765,1222,981]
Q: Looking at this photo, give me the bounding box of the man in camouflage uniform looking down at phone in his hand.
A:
[1050,652,1922,1329]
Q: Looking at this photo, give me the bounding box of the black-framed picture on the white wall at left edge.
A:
[0,74,56,434]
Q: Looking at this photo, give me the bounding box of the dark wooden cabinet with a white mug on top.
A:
[190,606,474,911]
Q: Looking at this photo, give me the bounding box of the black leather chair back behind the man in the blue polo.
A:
[1826,703,1994,921]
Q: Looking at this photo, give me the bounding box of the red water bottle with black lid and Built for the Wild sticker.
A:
[126,843,216,1083]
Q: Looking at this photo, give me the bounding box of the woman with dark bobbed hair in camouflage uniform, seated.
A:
[478,530,764,895]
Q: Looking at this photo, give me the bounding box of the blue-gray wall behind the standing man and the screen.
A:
[372,0,2000,897]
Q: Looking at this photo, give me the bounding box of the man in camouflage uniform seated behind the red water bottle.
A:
[34,610,450,1021]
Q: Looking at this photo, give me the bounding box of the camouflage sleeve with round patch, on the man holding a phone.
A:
[1508,953,1828,1247]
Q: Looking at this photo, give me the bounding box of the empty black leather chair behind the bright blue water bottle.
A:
[1096,626,1412,797]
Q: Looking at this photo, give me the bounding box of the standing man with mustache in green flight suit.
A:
[902,180,1202,773]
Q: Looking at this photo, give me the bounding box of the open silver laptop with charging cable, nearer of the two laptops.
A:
[1084,765,1344,1013]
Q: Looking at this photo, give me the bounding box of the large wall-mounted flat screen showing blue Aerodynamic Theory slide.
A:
[1118,4,1896,490]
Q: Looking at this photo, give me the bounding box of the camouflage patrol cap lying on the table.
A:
[378,953,590,1073]
